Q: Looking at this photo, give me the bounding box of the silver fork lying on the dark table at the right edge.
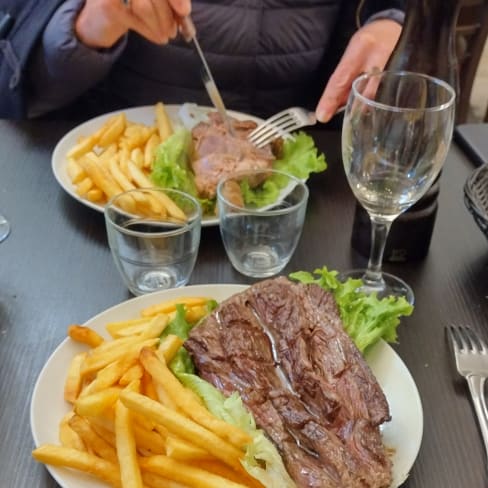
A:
[447,325,488,455]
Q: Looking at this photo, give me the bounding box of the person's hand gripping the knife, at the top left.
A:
[75,0,191,49]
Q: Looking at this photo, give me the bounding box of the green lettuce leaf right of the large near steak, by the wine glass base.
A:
[290,267,413,353]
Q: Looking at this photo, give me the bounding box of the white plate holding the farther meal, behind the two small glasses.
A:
[51,105,263,227]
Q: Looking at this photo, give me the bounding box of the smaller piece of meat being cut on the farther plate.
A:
[192,112,275,198]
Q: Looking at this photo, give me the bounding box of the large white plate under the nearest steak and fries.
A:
[30,285,423,488]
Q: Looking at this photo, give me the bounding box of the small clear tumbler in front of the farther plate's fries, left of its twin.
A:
[105,188,202,295]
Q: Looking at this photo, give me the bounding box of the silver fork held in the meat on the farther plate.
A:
[248,107,317,147]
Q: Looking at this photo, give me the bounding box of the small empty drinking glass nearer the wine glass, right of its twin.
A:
[217,169,308,278]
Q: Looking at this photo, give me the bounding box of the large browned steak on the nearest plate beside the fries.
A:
[185,277,392,488]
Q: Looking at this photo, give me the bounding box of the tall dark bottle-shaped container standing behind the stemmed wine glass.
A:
[351,0,460,262]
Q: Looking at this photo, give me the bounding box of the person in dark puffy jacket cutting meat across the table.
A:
[0,0,404,122]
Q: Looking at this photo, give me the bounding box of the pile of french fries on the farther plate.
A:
[66,102,185,220]
